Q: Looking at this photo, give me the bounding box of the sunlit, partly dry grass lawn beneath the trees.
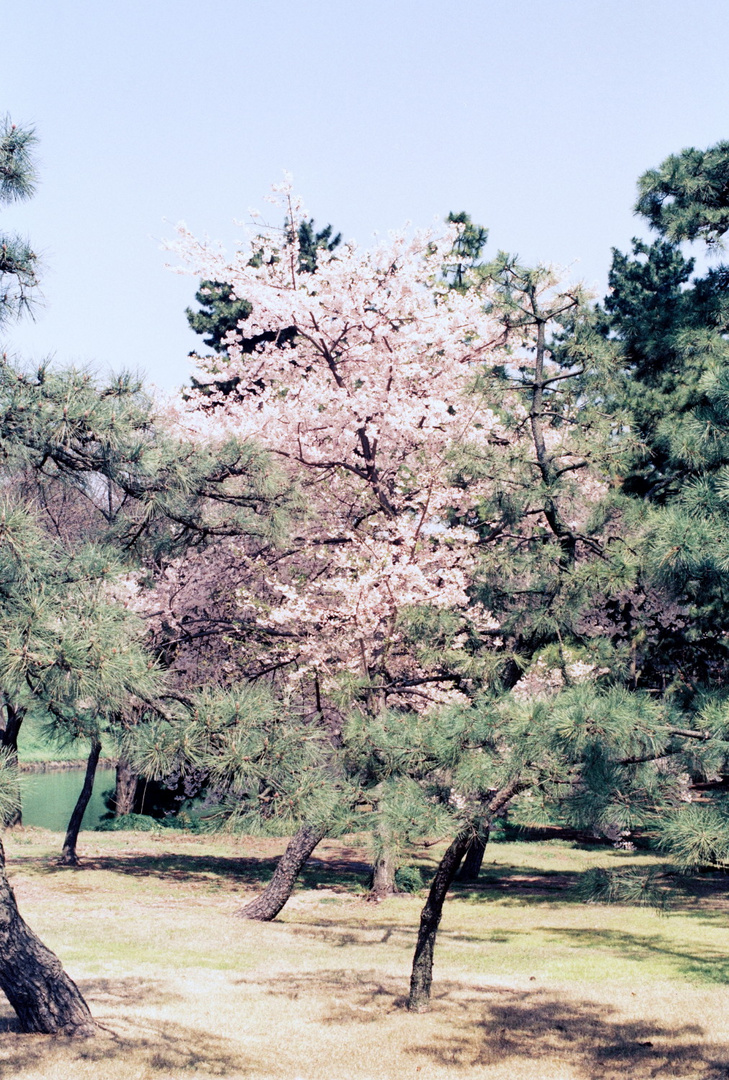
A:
[0,828,729,1080]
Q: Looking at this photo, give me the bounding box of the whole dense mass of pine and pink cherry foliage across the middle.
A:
[0,118,729,1028]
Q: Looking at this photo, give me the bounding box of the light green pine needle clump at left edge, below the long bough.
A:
[0,501,163,756]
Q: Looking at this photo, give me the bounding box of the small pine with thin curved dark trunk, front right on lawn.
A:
[408,672,728,1012]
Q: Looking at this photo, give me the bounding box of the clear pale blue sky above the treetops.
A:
[0,0,729,388]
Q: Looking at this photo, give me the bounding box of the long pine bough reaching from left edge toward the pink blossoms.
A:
[0,360,295,558]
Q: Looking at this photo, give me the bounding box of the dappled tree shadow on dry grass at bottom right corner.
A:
[240,970,729,1080]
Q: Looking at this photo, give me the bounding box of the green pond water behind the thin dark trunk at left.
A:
[21,766,116,833]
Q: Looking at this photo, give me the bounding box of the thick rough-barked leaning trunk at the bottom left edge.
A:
[0,842,96,1036]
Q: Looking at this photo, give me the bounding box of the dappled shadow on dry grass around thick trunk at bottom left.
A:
[0,978,254,1080]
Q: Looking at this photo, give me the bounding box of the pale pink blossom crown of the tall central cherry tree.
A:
[171,183,514,704]
